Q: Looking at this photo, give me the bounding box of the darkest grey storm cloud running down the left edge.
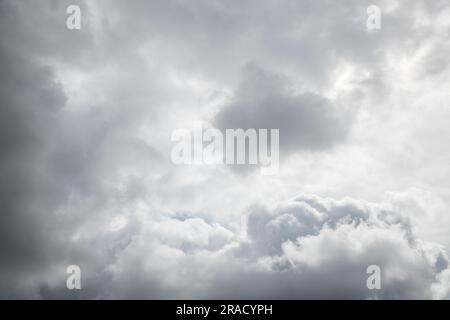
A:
[0,42,103,298]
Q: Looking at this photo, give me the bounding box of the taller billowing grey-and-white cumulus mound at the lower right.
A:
[230,196,448,299]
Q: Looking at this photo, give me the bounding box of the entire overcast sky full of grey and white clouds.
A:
[0,0,450,299]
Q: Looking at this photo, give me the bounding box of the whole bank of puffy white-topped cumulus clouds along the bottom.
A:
[59,192,449,299]
